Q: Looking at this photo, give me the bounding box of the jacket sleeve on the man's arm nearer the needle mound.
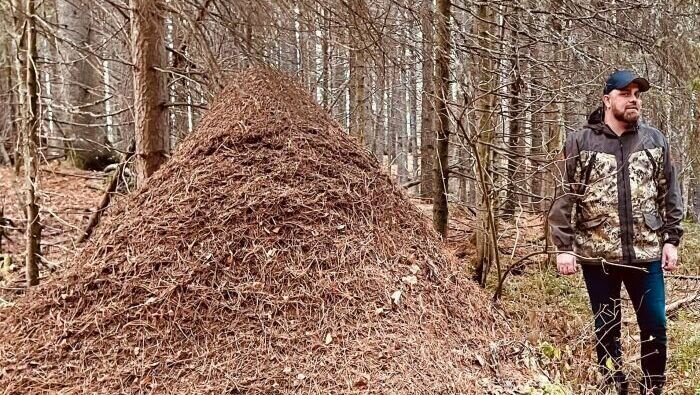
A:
[548,133,580,251]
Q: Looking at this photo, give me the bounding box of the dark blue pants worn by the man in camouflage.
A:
[582,261,666,386]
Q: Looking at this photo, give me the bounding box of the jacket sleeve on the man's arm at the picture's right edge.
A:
[657,139,683,245]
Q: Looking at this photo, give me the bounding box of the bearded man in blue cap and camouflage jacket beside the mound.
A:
[549,70,683,394]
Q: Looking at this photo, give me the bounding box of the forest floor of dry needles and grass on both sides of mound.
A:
[0,165,700,395]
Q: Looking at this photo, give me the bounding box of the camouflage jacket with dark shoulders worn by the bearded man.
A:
[549,109,683,264]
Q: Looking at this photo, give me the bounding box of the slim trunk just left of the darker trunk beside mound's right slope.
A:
[420,0,435,198]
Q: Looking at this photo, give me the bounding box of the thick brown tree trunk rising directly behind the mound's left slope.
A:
[130,0,170,187]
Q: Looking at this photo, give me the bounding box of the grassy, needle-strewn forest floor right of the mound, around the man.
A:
[419,204,700,395]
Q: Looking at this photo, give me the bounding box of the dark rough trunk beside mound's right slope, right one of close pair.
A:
[433,0,451,238]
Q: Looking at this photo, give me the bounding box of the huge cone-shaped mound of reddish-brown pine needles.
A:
[0,70,517,394]
